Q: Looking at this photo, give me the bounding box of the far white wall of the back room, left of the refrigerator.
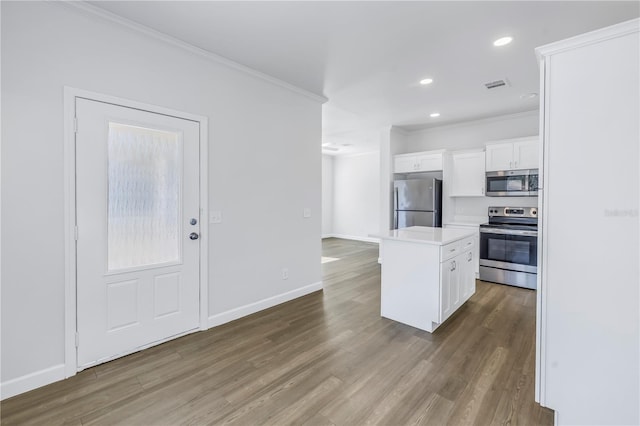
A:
[333,152,380,241]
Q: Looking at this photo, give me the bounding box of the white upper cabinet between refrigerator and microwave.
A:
[451,151,485,197]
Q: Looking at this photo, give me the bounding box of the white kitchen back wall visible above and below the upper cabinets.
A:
[404,110,539,223]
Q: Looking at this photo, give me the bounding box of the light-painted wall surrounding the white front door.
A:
[1,2,321,397]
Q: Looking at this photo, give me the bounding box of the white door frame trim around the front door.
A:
[64,86,209,377]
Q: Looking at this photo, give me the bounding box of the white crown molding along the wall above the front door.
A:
[57,0,329,103]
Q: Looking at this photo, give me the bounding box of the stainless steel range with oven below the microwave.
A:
[480,207,538,289]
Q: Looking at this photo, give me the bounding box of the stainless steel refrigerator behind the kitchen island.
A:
[393,179,442,229]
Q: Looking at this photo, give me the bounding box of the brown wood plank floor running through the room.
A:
[1,239,553,425]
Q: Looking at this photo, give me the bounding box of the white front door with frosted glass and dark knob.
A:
[76,98,200,370]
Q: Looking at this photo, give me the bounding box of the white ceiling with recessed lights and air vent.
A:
[90,1,640,154]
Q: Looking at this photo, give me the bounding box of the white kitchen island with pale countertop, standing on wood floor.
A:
[378,226,476,332]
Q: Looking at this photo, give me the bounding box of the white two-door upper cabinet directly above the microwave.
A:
[486,136,539,172]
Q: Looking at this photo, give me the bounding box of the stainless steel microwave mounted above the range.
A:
[485,169,538,197]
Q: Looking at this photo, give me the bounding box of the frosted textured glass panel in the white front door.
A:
[107,122,183,271]
